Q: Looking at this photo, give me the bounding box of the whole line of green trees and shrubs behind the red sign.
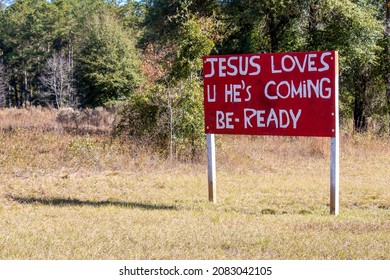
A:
[0,0,390,153]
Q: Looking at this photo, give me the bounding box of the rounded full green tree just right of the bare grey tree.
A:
[76,14,141,106]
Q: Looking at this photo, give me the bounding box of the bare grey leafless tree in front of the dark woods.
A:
[40,53,77,108]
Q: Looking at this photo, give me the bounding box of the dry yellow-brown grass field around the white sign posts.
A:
[0,108,390,259]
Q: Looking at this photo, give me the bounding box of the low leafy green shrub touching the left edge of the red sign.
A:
[116,76,204,160]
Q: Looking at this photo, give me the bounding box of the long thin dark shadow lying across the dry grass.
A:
[10,196,177,210]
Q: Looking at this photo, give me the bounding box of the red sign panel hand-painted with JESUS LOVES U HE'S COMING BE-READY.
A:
[203,51,338,137]
